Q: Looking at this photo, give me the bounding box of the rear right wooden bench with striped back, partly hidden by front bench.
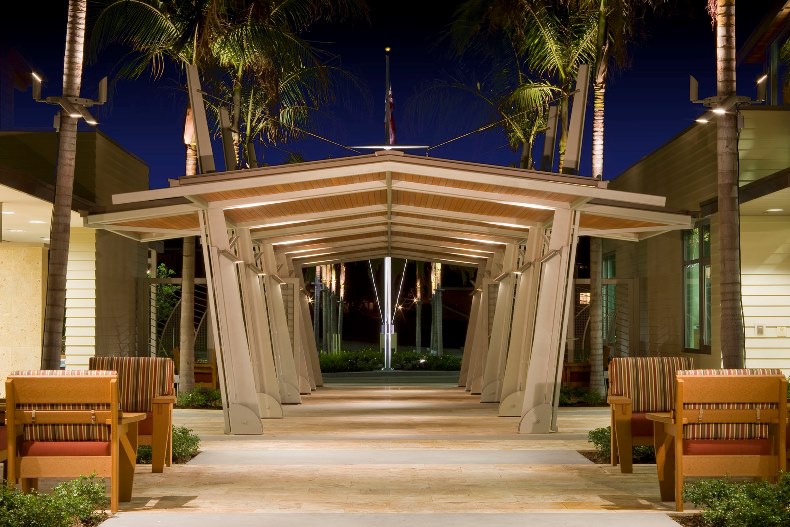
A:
[607,357,694,474]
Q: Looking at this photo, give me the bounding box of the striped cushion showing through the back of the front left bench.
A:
[9,370,116,442]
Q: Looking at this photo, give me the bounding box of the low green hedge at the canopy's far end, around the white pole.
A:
[319,349,461,373]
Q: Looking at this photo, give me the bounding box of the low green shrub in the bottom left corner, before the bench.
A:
[0,476,108,527]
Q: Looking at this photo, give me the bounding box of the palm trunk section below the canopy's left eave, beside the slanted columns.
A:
[178,236,195,392]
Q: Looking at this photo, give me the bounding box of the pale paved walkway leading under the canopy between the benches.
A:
[105,378,678,527]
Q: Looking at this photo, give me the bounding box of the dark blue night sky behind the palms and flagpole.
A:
[3,0,769,188]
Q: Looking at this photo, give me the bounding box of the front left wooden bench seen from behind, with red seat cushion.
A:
[6,370,145,512]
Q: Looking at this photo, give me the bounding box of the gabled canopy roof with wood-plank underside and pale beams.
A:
[85,150,692,266]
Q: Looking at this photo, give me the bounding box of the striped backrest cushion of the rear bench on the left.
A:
[88,357,175,412]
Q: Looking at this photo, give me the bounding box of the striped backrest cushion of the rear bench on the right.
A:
[609,357,694,413]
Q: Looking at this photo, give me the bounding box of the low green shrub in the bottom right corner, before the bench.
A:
[683,473,790,527]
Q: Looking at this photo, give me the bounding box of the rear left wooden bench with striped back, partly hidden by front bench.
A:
[88,357,176,473]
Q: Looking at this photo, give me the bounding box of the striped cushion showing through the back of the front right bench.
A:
[677,368,783,441]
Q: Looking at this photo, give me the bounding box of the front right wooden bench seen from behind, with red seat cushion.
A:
[649,369,787,511]
